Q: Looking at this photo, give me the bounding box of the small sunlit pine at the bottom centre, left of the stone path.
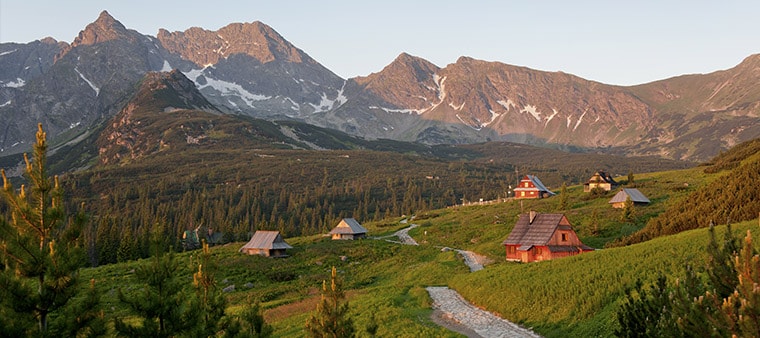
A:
[306,266,354,338]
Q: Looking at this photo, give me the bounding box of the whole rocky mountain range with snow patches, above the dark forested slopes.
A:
[0,11,760,161]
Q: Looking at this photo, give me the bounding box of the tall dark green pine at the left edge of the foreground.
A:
[0,124,87,336]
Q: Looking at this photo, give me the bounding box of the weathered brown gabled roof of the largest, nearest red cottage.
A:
[502,213,565,250]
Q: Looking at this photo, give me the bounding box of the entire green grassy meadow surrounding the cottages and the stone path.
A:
[74,168,760,337]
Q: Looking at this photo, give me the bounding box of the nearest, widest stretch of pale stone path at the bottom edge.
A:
[426,286,541,338]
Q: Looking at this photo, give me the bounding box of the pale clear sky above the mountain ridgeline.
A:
[0,0,760,85]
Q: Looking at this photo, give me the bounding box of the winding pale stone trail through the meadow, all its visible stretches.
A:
[376,224,541,338]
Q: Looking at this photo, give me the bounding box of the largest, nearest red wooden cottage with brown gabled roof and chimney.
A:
[502,211,594,263]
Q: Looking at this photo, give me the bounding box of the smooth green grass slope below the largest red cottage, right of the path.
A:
[450,221,757,337]
